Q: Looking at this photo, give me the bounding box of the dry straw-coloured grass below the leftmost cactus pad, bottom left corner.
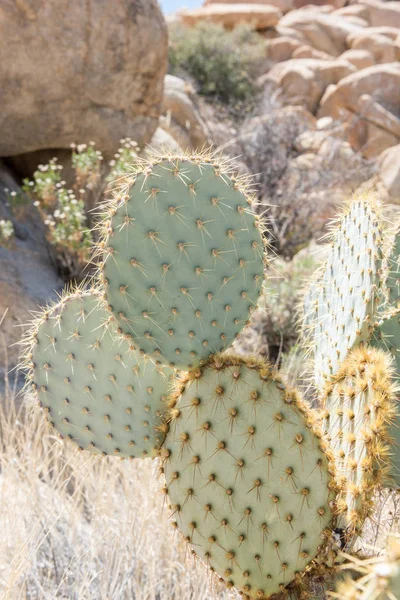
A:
[0,378,235,600]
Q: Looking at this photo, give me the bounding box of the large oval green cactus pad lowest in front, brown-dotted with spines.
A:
[162,356,332,598]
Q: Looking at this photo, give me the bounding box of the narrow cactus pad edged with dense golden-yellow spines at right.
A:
[321,346,397,539]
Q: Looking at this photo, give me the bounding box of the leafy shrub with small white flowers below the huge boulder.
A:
[23,138,139,280]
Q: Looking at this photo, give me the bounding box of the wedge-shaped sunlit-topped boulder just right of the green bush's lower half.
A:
[261,58,355,112]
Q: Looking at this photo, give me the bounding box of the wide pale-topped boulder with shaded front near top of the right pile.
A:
[279,8,367,56]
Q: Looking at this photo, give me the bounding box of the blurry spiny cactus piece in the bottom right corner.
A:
[332,535,400,600]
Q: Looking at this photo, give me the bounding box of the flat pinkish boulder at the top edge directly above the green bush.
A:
[179,3,282,30]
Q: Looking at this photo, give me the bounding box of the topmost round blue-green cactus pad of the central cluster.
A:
[97,155,265,369]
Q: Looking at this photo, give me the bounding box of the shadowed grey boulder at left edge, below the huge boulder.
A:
[0,162,63,376]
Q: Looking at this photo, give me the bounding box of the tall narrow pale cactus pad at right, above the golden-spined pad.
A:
[304,196,382,390]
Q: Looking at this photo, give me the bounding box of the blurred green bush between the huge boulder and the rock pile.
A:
[169,23,265,104]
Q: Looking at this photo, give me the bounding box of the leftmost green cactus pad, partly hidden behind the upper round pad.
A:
[25,290,172,458]
